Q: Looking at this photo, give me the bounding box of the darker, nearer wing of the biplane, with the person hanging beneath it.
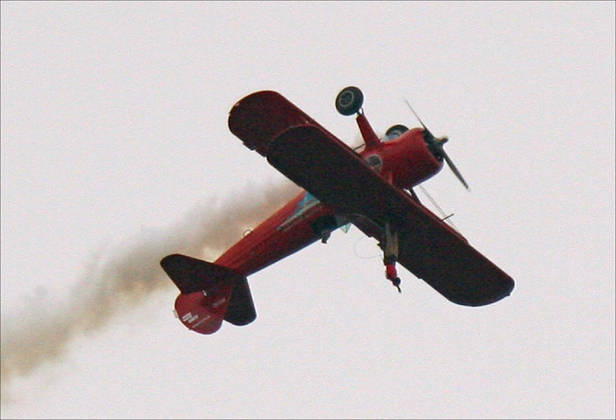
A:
[267,125,514,306]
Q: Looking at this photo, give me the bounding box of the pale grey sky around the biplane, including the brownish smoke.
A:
[1,2,615,418]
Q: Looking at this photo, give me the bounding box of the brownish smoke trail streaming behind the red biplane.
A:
[1,182,299,401]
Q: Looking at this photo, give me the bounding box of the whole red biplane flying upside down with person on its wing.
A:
[161,86,514,334]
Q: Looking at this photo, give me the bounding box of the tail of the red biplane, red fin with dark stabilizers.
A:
[160,254,257,334]
